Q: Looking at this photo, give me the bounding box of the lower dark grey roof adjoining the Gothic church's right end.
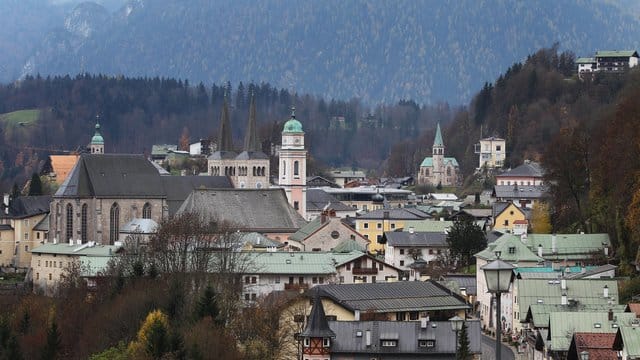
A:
[159,175,233,216]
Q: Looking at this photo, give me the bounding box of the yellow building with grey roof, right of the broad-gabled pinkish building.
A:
[355,208,430,254]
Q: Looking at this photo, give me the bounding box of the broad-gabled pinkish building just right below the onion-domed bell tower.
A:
[288,210,371,252]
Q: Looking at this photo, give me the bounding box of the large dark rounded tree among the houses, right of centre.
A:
[447,216,487,267]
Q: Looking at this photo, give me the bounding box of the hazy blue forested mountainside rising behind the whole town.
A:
[0,0,640,104]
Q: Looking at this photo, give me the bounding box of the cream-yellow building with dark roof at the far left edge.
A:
[0,194,51,268]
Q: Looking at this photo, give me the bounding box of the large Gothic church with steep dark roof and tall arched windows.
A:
[49,154,231,244]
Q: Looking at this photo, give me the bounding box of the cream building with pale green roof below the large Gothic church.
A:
[30,241,121,295]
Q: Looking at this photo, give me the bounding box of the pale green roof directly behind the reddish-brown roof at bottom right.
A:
[549,311,635,351]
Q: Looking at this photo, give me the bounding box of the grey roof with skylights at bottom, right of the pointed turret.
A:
[329,320,481,359]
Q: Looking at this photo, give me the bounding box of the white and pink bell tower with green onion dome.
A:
[278,107,307,219]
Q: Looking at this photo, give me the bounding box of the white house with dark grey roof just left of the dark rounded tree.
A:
[383,228,449,275]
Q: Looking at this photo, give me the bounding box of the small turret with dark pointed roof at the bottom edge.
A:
[300,291,336,360]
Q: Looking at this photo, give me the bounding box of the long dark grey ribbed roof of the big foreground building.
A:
[318,280,469,313]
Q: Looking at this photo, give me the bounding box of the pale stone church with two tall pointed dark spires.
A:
[207,95,271,189]
